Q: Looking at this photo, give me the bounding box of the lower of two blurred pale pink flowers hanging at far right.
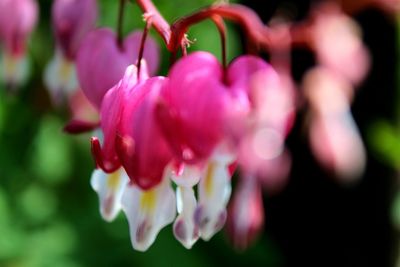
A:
[303,67,366,182]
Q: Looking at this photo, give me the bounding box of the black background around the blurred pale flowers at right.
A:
[245,0,398,267]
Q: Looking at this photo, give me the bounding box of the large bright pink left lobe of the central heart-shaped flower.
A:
[158,52,228,163]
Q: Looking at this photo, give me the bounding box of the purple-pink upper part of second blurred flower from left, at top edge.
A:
[52,0,97,59]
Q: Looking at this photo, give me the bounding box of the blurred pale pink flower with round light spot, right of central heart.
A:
[228,56,295,189]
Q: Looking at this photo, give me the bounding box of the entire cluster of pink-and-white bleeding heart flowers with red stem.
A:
[0,0,394,251]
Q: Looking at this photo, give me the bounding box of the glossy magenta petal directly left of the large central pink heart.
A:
[116,77,172,190]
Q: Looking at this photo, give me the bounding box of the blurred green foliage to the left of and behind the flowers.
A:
[0,0,282,267]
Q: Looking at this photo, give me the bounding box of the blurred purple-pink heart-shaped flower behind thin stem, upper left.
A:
[77,28,158,109]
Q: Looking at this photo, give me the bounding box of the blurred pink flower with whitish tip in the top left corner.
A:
[0,0,38,86]
